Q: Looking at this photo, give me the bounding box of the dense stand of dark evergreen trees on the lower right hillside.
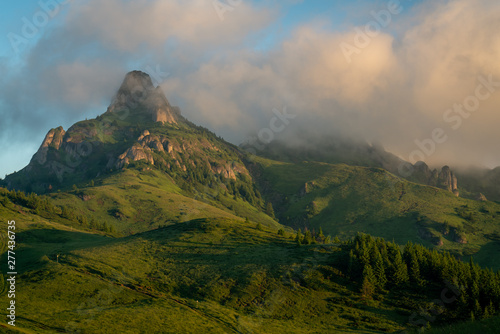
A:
[343,235,500,320]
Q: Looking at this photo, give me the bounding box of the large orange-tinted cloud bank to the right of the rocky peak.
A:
[161,0,500,165]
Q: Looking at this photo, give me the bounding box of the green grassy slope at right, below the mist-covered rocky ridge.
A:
[255,158,500,269]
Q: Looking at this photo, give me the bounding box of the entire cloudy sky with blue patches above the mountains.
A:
[0,0,500,177]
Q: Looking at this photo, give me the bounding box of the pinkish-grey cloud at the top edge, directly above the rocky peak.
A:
[68,0,271,52]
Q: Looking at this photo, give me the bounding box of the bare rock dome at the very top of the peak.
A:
[108,71,181,124]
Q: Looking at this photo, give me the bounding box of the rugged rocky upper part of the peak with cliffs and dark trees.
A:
[4,71,249,193]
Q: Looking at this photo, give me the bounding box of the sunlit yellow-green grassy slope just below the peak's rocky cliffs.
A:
[47,169,281,235]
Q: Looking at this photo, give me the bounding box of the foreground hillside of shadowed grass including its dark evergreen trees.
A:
[0,189,499,333]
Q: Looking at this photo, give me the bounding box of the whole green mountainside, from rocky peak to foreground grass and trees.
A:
[0,73,500,333]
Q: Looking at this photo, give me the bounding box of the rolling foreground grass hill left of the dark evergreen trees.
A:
[0,206,408,333]
